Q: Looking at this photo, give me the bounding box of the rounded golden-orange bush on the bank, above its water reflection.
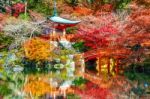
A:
[23,38,54,61]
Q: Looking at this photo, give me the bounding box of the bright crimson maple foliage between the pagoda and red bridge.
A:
[74,25,118,49]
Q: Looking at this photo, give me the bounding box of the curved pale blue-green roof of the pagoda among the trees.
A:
[48,16,80,24]
